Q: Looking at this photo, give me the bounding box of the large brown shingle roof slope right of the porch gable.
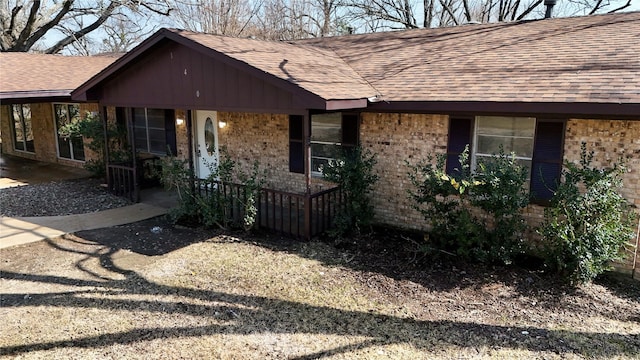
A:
[295,12,640,104]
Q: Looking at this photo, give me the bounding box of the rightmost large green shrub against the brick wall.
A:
[538,143,637,283]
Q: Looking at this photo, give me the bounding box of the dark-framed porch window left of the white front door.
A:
[133,108,176,155]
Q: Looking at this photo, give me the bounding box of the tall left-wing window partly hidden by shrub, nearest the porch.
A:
[53,104,85,161]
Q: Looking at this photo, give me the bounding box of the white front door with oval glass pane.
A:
[194,110,218,179]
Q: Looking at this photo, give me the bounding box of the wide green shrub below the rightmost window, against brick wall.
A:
[408,146,528,264]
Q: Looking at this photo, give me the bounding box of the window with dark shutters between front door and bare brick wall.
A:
[289,113,359,176]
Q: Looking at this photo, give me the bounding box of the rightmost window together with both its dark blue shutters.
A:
[447,116,565,204]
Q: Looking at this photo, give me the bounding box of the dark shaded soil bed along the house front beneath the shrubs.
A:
[66,216,640,319]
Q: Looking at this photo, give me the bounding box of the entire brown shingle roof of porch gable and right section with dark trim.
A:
[74,12,640,112]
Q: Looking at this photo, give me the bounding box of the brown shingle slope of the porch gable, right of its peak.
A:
[171,30,376,100]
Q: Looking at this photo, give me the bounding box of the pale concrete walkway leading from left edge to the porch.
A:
[0,203,168,249]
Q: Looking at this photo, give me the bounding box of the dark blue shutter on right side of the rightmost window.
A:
[531,119,565,204]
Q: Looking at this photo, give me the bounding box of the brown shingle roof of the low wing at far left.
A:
[0,52,117,99]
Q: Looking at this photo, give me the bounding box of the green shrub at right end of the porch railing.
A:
[322,147,378,239]
